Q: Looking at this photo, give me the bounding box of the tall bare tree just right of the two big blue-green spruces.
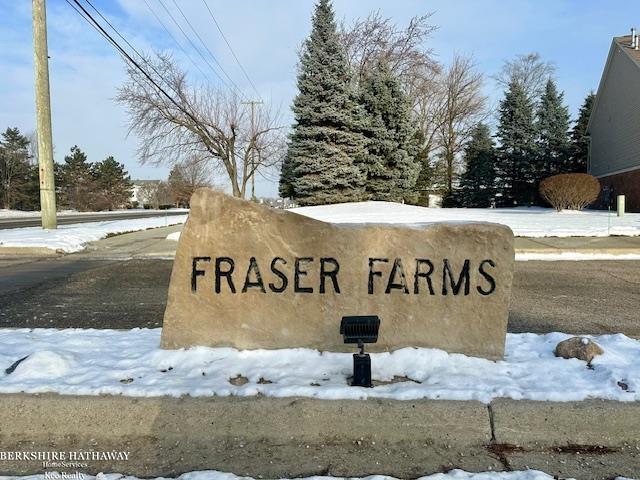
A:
[435,54,487,194]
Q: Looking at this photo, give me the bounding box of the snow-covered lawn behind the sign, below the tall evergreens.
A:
[290,202,640,237]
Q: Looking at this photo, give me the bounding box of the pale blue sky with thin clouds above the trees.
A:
[0,0,640,196]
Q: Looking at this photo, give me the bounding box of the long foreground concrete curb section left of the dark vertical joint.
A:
[0,394,502,478]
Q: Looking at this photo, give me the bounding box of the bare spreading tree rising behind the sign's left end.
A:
[116,54,284,198]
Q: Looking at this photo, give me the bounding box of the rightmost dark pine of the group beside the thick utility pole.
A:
[91,156,133,210]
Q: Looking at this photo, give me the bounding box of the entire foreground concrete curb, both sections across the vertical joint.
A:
[0,394,640,479]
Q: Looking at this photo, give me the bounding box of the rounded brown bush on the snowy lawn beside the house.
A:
[540,173,600,211]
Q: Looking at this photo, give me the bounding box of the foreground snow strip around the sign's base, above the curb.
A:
[0,329,640,403]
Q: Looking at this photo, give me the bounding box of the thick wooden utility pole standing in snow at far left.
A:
[33,0,58,229]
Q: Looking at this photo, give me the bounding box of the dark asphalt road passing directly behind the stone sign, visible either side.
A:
[0,255,640,338]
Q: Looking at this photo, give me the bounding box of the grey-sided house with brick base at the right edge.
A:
[587,30,640,212]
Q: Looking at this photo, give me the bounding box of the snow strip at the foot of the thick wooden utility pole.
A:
[0,215,188,253]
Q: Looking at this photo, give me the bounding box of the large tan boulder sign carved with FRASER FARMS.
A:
[162,189,514,359]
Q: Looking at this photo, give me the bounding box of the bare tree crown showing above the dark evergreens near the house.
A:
[493,52,556,102]
